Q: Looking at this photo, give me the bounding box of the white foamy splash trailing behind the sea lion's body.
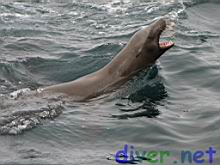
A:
[0,88,64,135]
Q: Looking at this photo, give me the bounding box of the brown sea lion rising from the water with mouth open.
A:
[41,19,174,101]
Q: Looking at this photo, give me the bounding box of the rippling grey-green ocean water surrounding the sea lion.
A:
[0,0,220,165]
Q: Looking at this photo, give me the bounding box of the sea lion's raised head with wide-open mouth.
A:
[119,19,174,77]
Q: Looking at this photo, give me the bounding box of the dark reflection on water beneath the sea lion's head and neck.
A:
[112,65,167,119]
